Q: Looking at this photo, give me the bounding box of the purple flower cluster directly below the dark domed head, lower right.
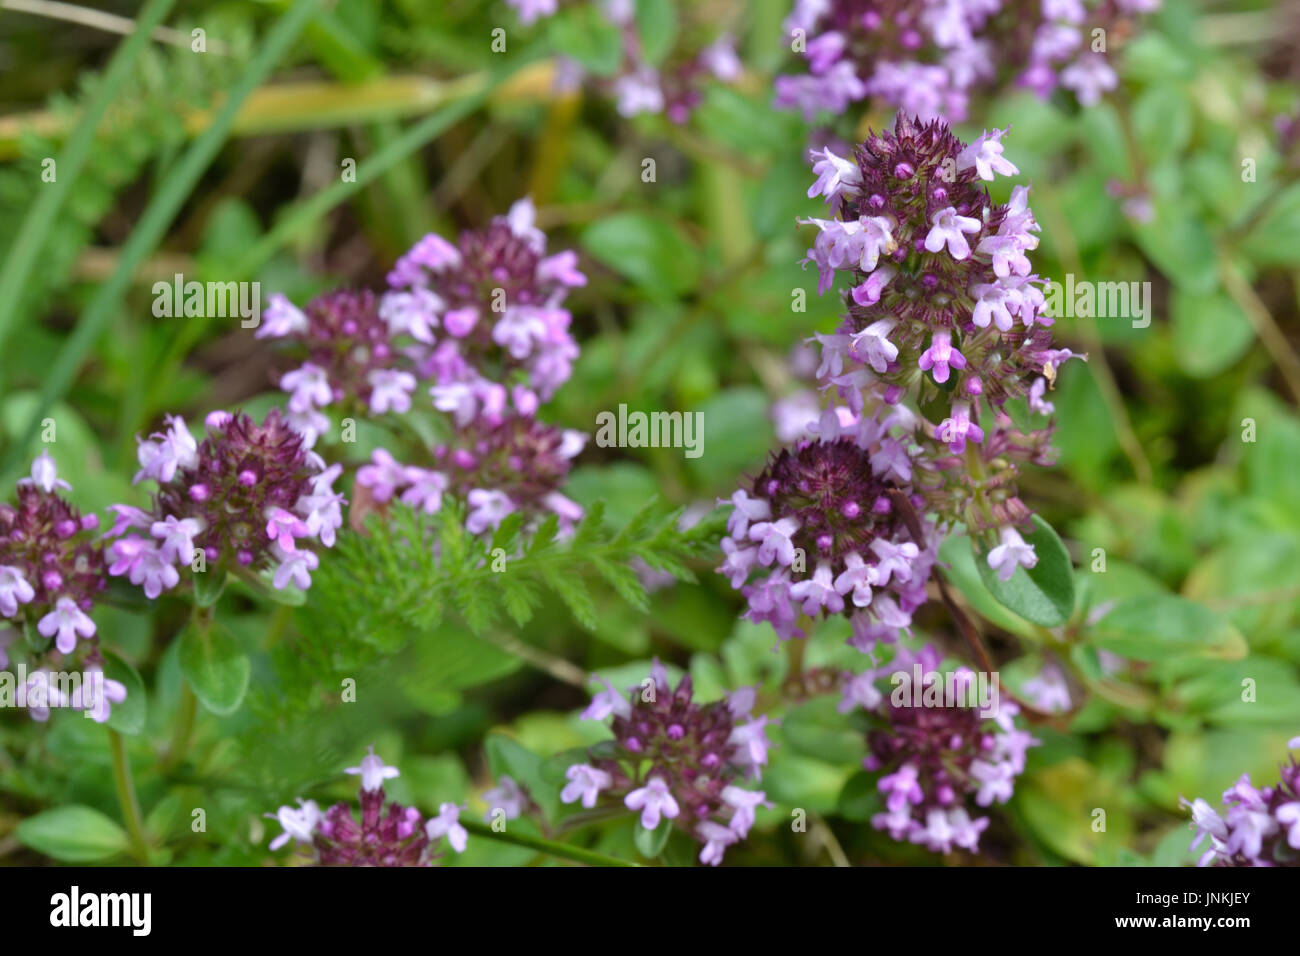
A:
[840,646,1037,853]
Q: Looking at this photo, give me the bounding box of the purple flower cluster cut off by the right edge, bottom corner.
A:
[1183,737,1300,866]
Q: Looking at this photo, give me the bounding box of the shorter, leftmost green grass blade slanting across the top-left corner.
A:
[0,0,176,358]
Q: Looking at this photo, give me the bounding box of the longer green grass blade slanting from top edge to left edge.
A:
[0,0,317,473]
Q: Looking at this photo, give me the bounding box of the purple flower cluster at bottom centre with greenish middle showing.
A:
[560,661,768,866]
